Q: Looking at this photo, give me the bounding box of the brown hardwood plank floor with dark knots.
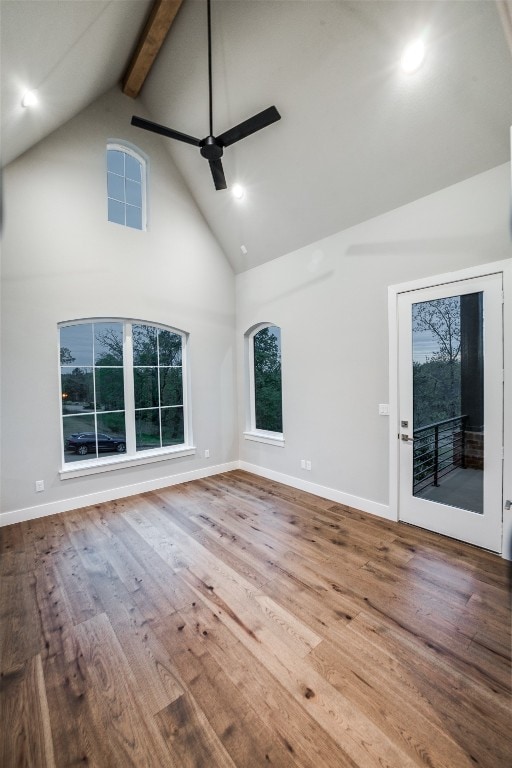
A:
[0,471,512,768]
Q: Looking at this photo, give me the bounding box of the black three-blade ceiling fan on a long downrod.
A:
[131,0,281,189]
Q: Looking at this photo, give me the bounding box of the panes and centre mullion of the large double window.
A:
[59,320,190,464]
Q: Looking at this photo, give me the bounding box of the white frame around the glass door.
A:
[388,259,512,560]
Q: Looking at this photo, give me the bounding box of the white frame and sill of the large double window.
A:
[57,317,196,480]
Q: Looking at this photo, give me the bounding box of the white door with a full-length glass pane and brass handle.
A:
[398,275,503,551]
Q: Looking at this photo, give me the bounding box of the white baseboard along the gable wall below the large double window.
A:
[0,461,239,527]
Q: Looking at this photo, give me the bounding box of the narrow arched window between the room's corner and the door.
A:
[244,323,284,444]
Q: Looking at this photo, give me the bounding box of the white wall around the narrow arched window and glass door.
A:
[236,164,512,517]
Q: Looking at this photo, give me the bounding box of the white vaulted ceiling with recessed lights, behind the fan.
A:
[0,0,512,272]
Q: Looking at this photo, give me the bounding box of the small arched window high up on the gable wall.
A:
[107,143,146,229]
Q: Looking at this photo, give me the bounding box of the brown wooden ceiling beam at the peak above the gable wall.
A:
[123,0,183,99]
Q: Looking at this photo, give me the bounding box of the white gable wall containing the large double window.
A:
[0,89,238,522]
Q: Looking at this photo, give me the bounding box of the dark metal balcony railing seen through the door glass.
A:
[413,416,468,495]
